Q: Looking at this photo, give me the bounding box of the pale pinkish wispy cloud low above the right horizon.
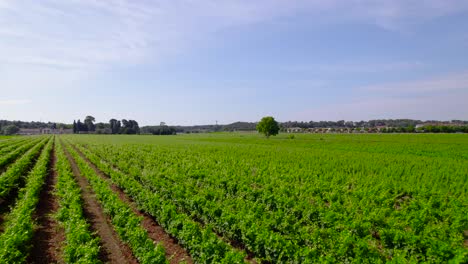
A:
[296,72,468,120]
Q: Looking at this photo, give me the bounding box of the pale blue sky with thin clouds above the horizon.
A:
[0,0,468,125]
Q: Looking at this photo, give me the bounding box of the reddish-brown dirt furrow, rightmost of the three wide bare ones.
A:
[72,145,193,264]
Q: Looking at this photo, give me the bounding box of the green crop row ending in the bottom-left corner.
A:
[0,138,54,263]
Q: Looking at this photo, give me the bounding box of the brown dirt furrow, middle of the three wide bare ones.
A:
[62,143,138,264]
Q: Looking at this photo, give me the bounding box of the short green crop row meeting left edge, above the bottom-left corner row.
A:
[0,138,49,200]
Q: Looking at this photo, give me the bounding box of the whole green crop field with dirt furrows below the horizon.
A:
[0,133,468,263]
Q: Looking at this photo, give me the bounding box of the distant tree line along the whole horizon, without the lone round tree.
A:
[0,116,468,135]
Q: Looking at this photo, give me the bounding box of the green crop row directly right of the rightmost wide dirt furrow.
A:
[68,139,249,263]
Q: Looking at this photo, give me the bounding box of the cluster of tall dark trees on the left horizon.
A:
[73,116,140,135]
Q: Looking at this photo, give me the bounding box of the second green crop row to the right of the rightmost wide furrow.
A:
[73,142,314,263]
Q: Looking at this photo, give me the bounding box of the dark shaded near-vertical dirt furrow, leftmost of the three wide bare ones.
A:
[28,147,65,264]
